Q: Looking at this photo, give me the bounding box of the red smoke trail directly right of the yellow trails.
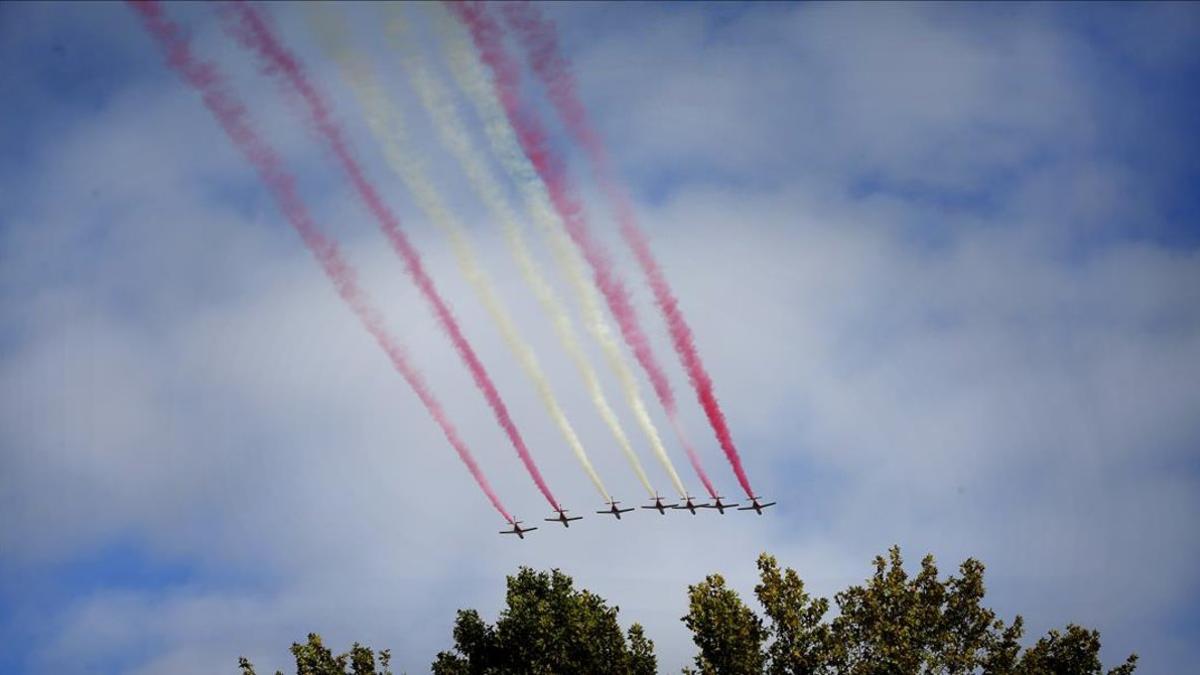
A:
[445,2,716,497]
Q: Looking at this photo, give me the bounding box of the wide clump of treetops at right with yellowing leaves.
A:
[683,546,1138,675]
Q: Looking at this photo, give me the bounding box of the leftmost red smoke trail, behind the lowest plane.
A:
[130,0,512,522]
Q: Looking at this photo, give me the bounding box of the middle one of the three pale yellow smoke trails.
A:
[388,5,655,497]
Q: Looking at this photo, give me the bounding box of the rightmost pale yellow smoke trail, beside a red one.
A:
[437,7,688,496]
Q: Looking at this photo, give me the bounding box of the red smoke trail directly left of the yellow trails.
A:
[226,1,559,509]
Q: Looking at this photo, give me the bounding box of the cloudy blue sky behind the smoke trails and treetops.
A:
[0,2,1200,675]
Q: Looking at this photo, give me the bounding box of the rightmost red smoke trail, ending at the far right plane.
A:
[500,1,754,497]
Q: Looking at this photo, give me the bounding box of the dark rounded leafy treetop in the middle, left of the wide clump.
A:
[432,568,656,675]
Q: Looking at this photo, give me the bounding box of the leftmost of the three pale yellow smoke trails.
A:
[310,4,612,501]
